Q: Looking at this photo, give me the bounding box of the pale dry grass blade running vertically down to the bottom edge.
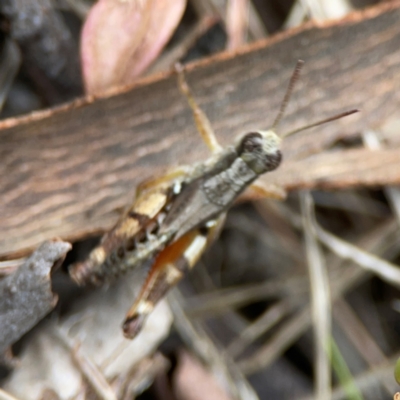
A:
[300,192,332,399]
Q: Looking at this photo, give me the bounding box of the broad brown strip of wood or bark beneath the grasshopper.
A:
[0,2,400,257]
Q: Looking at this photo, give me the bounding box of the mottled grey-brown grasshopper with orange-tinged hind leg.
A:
[69,61,358,338]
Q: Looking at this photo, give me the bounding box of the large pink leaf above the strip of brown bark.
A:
[81,0,186,94]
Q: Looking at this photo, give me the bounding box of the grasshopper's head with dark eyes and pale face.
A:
[236,130,282,175]
